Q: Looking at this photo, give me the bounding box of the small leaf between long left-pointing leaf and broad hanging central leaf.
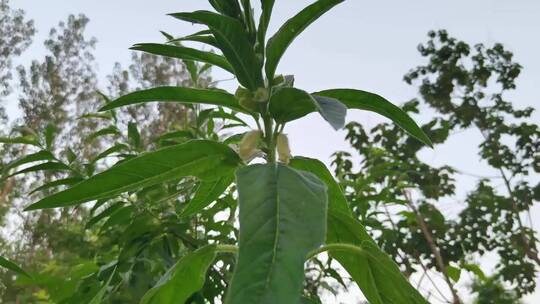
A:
[180,174,234,217]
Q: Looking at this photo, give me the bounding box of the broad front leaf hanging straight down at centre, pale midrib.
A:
[225,164,327,304]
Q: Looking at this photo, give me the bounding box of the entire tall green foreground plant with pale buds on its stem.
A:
[3,0,431,304]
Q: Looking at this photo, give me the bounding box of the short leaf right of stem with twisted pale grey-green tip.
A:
[269,88,347,130]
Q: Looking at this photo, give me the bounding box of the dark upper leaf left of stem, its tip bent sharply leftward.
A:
[171,11,264,91]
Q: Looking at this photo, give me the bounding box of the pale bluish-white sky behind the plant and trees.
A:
[8,0,540,304]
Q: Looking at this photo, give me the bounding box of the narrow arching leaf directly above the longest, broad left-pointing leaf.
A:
[100,87,246,113]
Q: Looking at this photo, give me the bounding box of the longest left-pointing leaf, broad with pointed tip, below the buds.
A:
[26,140,240,210]
